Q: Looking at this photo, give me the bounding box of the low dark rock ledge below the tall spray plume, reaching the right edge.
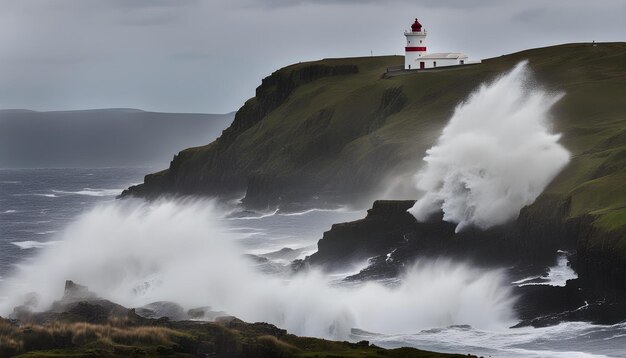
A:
[294,200,626,326]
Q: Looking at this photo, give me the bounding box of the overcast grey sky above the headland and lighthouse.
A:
[0,0,626,113]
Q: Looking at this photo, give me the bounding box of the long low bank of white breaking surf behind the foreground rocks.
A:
[0,200,513,339]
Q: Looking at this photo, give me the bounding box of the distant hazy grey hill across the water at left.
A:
[0,109,234,168]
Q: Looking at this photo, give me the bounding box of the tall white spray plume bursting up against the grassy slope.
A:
[410,62,569,231]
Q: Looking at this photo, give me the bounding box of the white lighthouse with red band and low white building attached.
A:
[404,19,480,70]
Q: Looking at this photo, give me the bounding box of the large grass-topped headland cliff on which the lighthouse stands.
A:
[123,43,626,300]
